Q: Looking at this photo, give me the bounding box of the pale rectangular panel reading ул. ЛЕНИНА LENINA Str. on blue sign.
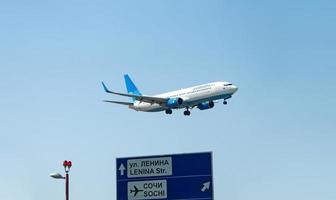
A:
[127,157,173,178]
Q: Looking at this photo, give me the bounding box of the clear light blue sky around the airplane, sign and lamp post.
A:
[0,1,336,200]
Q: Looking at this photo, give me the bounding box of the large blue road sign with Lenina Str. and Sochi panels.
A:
[116,152,213,200]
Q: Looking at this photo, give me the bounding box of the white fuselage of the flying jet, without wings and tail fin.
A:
[129,82,238,112]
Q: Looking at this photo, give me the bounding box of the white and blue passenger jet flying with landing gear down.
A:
[102,74,238,116]
